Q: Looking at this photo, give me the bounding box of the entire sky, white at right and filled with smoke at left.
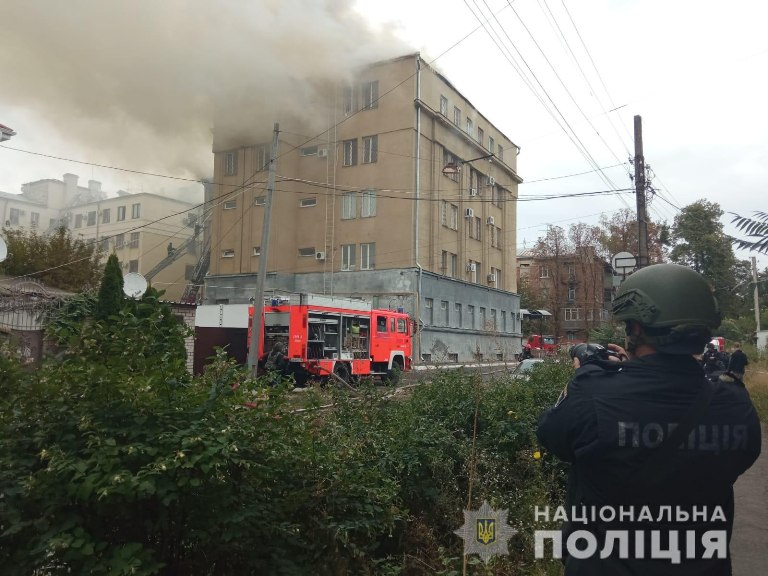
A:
[0,0,768,268]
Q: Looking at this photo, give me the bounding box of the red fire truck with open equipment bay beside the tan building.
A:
[248,294,413,383]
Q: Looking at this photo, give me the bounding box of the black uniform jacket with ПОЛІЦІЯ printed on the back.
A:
[537,354,761,576]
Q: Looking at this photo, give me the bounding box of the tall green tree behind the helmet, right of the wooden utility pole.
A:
[670,200,748,316]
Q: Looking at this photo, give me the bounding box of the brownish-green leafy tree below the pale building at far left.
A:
[0,226,101,292]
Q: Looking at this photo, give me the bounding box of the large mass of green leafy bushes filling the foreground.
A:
[0,291,570,575]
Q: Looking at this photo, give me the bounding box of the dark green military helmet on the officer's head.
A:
[613,264,720,333]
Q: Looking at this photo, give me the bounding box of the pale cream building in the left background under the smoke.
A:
[0,174,202,300]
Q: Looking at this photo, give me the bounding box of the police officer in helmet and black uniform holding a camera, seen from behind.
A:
[537,264,760,576]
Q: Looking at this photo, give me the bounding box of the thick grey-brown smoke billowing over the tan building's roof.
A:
[0,0,409,182]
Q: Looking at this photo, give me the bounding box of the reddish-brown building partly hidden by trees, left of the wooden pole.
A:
[517,248,614,344]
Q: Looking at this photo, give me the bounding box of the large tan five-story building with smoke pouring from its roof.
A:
[205,54,521,361]
